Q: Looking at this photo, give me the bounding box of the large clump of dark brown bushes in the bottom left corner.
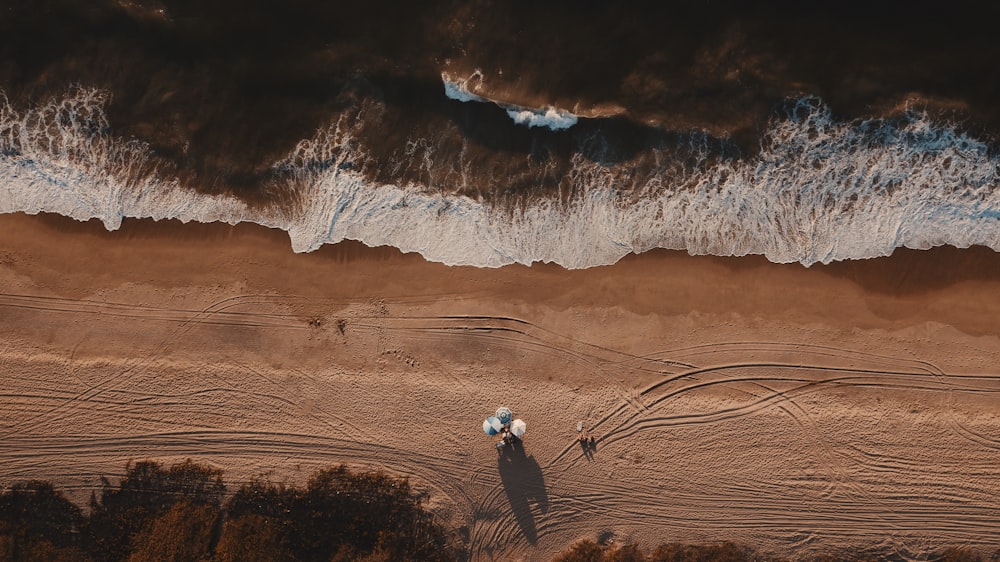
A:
[0,461,456,562]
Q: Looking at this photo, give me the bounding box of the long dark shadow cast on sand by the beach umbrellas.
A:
[497,441,549,544]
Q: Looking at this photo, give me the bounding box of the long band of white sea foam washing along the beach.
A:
[0,90,1000,268]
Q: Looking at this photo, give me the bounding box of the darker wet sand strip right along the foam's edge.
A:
[11,209,1000,335]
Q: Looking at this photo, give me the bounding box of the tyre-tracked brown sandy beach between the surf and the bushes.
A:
[0,211,1000,560]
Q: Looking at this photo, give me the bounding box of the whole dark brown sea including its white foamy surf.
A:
[0,0,1000,267]
